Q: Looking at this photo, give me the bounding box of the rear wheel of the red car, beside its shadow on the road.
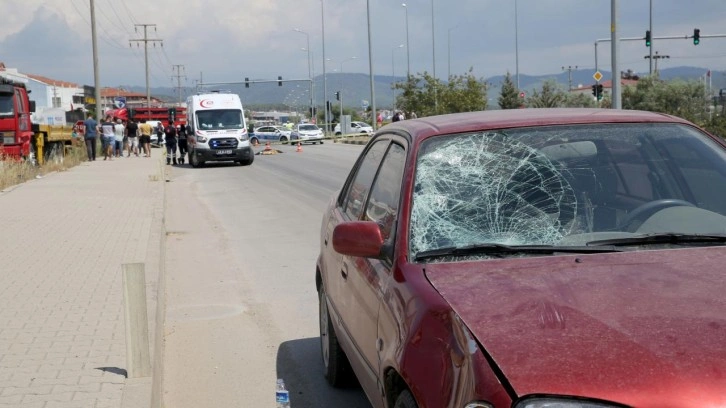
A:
[318,286,353,387]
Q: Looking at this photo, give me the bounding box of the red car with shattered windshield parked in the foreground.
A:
[316,109,726,408]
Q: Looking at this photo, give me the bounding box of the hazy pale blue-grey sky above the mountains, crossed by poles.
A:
[0,0,726,87]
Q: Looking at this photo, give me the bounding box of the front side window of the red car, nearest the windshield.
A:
[364,144,406,241]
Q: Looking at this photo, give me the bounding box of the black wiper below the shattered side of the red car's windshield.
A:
[415,243,621,261]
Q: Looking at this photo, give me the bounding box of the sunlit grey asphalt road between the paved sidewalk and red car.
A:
[162,143,370,408]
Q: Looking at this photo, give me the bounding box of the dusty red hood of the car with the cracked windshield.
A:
[425,247,726,407]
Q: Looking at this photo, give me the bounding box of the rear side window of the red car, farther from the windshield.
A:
[343,140,389,220]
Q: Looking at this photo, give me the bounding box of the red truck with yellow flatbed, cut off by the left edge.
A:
[0,77,74,165]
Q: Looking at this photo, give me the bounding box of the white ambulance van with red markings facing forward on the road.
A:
[187,92,255,167]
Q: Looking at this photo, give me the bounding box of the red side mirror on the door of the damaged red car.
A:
[333,221,383,258]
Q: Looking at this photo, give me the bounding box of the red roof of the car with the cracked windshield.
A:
[381,108,692,138]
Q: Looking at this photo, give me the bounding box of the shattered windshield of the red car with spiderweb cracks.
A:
[410,124,726,256]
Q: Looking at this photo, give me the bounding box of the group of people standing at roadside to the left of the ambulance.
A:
[83,114,187,164]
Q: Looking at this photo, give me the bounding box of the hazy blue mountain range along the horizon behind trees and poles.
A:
[124,66,726,111]
